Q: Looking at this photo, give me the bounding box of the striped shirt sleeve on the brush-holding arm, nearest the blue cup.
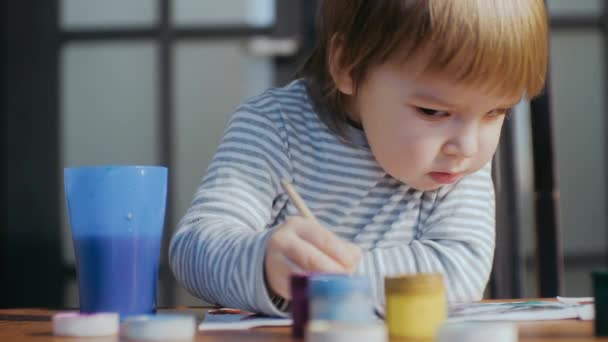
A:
[169,106,289,316]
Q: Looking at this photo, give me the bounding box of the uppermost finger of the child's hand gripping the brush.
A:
[297,224,361,270]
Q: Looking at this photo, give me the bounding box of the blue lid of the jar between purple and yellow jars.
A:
[309,274,370,298]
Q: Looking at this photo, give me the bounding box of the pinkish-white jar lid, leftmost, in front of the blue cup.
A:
[53,311,119,337]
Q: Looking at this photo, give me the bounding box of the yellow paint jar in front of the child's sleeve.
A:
[384,273,447,339]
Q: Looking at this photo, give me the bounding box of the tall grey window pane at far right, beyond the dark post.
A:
[551,31,607,295]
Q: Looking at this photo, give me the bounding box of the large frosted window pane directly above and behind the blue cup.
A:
[61,42,159,264]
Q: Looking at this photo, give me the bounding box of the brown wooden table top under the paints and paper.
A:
[0,307,608,342]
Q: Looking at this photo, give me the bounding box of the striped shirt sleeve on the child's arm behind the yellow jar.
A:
[357,163,495,305]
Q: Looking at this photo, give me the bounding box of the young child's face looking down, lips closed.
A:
[351,56,519,191]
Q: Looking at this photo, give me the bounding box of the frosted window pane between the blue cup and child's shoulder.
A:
[170,41,273,304]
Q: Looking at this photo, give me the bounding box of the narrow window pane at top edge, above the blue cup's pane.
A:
[61,0,158,29]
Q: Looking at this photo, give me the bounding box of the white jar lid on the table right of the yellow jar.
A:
[437,322,518,342]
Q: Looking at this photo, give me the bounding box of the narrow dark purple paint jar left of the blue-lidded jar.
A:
[290,273,311,338]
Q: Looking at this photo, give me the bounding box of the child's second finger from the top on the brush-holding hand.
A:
[283,238,346,273]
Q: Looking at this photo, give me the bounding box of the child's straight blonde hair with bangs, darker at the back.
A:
[299,0,548,136]
